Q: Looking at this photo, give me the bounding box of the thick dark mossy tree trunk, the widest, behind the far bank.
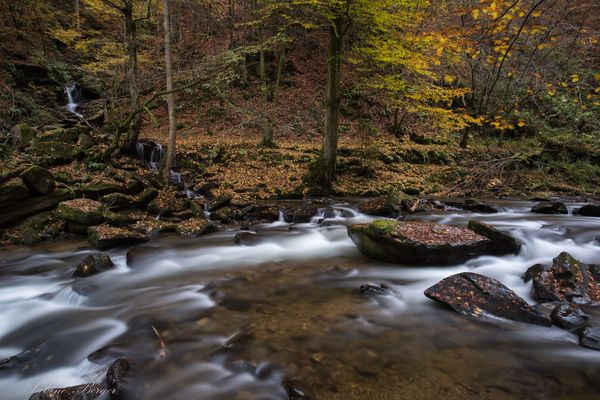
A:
[316,17,343,188]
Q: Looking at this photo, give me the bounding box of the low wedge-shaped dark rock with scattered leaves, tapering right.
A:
[425,272,552,326]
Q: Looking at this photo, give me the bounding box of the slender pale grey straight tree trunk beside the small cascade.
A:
[161,0,177,184]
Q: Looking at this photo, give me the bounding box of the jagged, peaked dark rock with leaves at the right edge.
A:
[526,252,600,304]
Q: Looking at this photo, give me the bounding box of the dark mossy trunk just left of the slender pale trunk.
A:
[122,2,142,152]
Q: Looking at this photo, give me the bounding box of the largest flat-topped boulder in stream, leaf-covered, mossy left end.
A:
[348,220,491,265]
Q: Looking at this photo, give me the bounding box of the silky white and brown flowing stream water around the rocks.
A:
[0,202,600,400]
